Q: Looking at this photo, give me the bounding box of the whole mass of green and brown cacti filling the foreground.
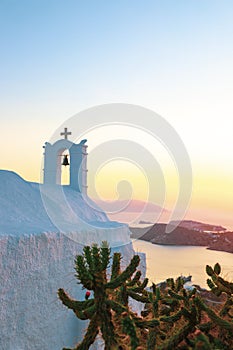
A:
[58,243,233,350]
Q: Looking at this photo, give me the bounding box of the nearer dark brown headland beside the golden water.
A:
[136,224,233,253]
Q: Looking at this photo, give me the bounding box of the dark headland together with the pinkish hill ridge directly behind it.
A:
[130,220,233,253]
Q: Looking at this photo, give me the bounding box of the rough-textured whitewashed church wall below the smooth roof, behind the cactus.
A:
[0,233,145,350]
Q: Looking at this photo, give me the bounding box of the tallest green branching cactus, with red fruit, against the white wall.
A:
[58,242,144,350]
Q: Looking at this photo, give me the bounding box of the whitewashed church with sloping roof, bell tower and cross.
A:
[0,128,145,350]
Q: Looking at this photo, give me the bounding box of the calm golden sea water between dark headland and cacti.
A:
[133,240,233,288]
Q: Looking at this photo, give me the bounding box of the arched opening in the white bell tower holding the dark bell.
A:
[57,149,70,185]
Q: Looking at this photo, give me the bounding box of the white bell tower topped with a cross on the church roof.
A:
[44,128,87,194]
